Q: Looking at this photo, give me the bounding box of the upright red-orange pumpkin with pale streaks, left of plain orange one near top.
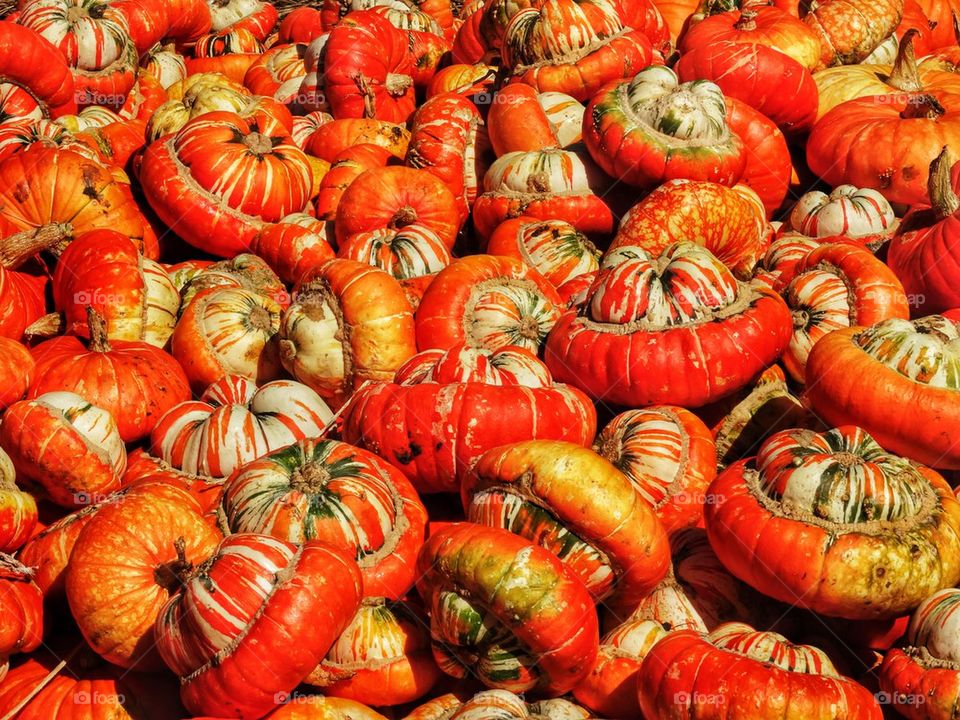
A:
[404,94,488,226]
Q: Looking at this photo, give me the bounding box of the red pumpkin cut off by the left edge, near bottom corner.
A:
[0,553,43,668]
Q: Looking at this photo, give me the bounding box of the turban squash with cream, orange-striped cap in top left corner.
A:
[17,0,138,107]
